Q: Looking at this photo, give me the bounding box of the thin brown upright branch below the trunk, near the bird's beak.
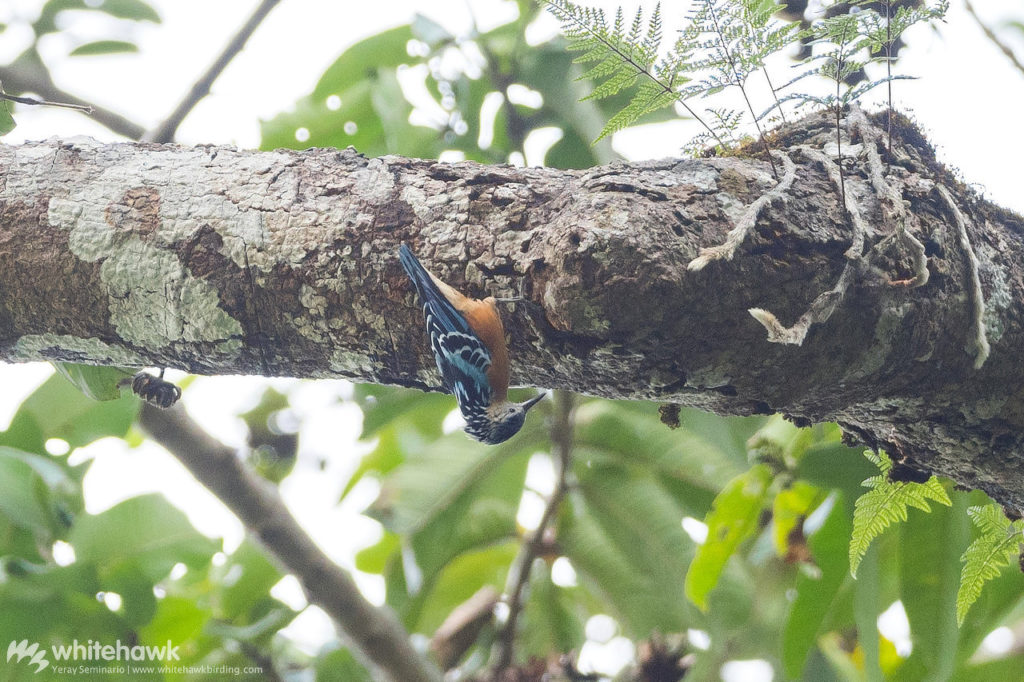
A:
[495,390,574,672]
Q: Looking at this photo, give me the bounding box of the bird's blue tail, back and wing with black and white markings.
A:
[398,244,492,417]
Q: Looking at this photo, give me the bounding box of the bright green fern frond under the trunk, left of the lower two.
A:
[850,451,952,578]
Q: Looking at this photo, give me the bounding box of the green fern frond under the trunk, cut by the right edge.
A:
[956,504,1024,625]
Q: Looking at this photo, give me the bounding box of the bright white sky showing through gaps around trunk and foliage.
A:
[0,0,1024,671]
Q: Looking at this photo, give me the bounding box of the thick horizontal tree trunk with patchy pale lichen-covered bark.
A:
[0,110,1024,509]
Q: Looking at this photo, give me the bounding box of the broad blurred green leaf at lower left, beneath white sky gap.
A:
[69,495,220,583]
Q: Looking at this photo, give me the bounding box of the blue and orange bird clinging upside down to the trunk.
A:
[398,244,545,445]
